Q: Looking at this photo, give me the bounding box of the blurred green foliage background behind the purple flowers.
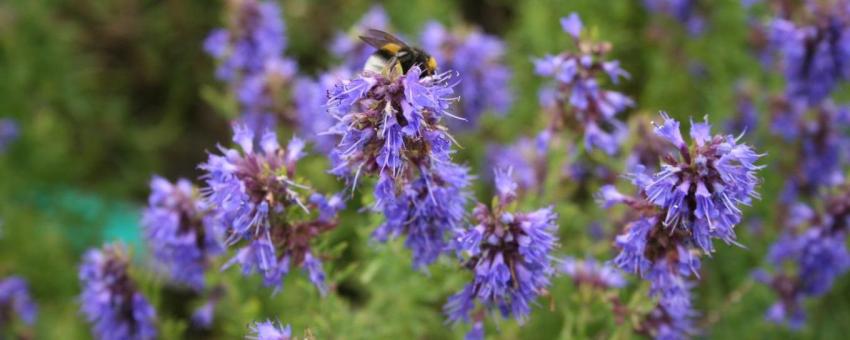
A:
[0,0,850,339]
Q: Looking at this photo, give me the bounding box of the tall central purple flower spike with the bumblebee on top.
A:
[328,67,470,268]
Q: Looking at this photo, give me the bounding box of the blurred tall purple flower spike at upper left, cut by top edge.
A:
[204,0,297,132]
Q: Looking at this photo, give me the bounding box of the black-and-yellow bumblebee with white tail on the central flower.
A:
[360,29,437,77]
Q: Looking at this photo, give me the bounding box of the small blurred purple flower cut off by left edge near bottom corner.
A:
[0,276,38,329]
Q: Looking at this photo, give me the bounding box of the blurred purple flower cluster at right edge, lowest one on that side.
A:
[756,185,850,329]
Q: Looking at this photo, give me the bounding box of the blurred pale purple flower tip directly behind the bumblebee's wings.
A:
[329,5,390,72]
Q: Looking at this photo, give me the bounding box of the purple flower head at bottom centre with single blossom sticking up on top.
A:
[444,170,558,321]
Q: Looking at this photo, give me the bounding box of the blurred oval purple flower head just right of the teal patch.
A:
[142,176,222,290]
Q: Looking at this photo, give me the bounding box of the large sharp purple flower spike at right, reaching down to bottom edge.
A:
[598,114,761,338]
